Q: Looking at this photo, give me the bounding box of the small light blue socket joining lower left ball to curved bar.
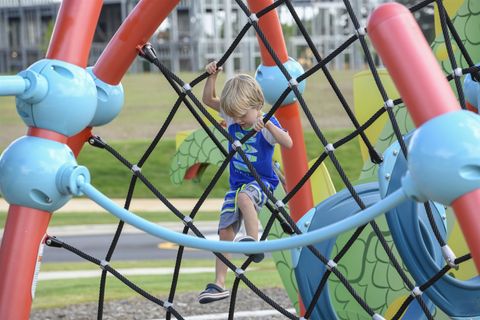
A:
[57,164,90,196]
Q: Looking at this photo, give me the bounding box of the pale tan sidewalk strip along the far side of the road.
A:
[0,198,223,212]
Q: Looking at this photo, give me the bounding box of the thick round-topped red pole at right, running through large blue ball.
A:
[368,3,480,272]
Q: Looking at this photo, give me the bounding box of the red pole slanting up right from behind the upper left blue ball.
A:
[93,0,180,85]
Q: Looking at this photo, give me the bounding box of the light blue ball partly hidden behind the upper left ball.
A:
[87,67,125,127]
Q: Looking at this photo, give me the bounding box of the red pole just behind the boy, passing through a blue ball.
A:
[248,0,313,221]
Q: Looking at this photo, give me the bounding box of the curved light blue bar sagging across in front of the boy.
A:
[77,177,407,254]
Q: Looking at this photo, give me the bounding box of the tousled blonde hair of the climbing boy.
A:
[220,74,265,117]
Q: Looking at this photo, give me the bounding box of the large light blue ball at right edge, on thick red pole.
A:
[402,110,480,205]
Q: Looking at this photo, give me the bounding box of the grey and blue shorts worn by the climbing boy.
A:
[218,181,272,233]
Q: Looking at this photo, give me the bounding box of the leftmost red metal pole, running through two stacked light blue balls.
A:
[0,0,103,320]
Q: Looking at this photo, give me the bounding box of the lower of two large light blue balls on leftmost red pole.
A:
[0,136,77,212]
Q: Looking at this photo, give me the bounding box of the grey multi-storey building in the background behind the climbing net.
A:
[0,0,390,73]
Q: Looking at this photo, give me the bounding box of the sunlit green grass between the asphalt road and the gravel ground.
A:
[33,258,282,308]
